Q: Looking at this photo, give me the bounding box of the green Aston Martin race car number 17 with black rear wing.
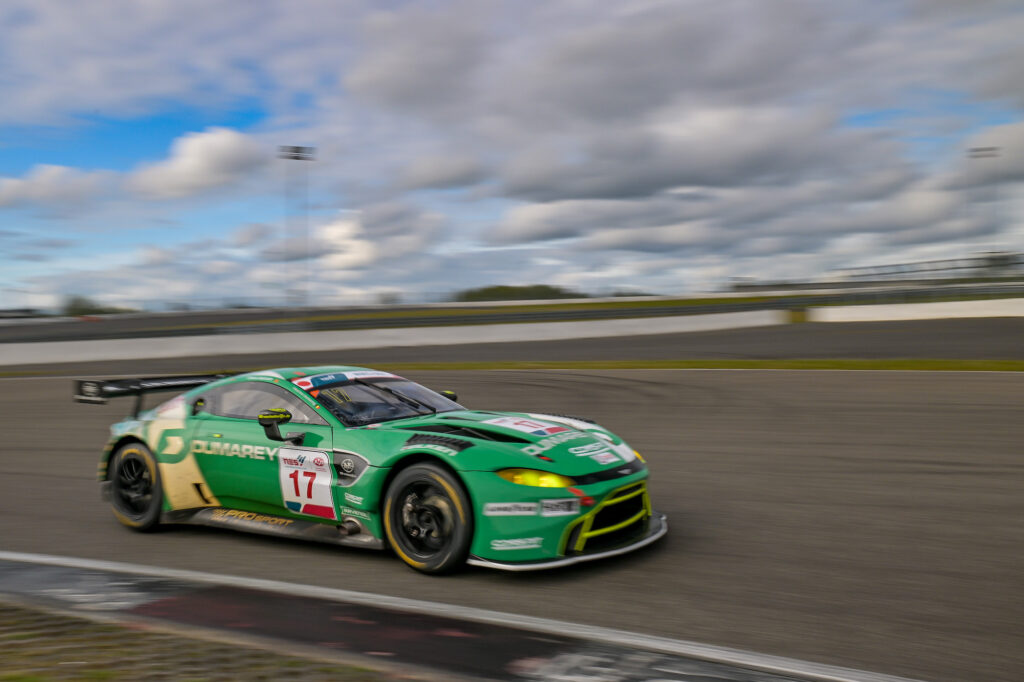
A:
[75,367,668,573]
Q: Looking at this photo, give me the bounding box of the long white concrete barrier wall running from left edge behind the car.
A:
[0,310,787,366]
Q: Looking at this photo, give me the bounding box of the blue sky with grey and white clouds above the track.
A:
[0,0,1024,307]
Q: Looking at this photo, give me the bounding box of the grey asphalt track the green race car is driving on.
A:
[0,364,1024,682]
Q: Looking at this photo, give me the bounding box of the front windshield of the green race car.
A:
[309,378,463,426]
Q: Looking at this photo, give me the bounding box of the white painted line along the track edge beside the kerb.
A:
[0,551,915,682]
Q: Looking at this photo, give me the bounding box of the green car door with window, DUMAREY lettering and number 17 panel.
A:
[190,381,337,519]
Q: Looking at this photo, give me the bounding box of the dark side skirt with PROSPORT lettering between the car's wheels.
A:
[160,507,384,549]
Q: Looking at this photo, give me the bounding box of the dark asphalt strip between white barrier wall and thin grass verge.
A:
[6,317,1024,375]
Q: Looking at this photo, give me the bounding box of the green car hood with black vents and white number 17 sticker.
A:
[379,410,636,476]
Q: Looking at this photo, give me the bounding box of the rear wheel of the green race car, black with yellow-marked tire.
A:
[110,442,164,532]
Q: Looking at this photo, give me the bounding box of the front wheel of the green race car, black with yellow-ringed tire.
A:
[382,464,473,574]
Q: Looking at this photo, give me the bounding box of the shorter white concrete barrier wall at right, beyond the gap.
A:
[807,298,1024,322]
